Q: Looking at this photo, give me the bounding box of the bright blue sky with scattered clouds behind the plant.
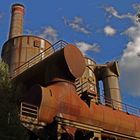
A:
[0,0,140,107]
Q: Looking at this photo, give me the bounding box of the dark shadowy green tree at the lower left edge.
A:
[0,60,28,140]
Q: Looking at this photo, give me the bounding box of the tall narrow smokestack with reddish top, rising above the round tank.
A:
[9,3,24,39]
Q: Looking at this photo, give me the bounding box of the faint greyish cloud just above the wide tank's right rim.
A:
[39,26,58,43]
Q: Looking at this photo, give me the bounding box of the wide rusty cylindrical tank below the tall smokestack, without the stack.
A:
[1,35,53,76]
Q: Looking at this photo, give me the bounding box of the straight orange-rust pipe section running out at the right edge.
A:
[89,102,140,139]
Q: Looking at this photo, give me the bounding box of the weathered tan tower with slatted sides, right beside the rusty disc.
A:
[75,57,97,95]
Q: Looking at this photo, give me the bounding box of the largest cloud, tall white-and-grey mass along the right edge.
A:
[119,19,140,96]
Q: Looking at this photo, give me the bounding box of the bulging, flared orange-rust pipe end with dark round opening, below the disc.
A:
[25,80,90,123]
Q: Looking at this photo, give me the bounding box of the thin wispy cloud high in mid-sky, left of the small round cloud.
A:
[63,17,91,35]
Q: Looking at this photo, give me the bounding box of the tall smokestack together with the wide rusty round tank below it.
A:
[1,3,53,77]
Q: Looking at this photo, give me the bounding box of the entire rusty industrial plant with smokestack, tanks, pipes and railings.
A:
[1,4,140,140]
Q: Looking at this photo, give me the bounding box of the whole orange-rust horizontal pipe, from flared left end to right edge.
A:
[25,80,140,139]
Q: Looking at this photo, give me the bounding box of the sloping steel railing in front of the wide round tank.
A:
[11,40,68,79]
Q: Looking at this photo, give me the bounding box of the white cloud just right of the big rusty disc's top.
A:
[75,42,100,55]
